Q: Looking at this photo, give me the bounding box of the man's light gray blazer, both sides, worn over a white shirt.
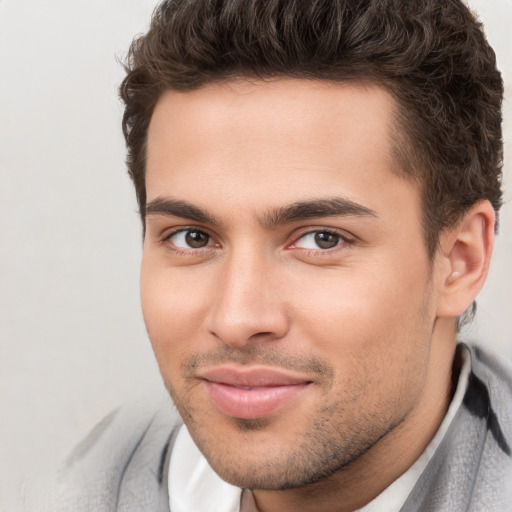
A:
[29,347,512,512]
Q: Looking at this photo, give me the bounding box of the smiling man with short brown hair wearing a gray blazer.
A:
[37,0,512,512]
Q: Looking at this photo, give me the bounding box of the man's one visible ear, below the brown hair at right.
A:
[437,201,496,317]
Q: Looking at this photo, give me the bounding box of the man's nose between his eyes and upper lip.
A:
[209,247,289,347]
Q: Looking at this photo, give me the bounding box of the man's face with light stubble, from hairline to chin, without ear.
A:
[141,79,442,489]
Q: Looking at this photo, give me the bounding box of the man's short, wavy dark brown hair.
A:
[120,0,503,256]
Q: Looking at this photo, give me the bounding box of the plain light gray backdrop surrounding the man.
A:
[0,0,512,512]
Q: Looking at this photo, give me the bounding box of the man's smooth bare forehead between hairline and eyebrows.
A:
[146,79,416,219]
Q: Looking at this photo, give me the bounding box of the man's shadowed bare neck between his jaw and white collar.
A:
[254,319,457,512]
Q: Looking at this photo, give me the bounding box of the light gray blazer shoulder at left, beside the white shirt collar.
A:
[27,395,182,512]
